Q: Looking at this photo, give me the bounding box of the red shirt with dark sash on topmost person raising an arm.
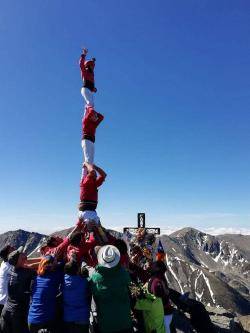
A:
[79,54,96,92]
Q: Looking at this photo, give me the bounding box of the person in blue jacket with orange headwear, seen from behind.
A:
[28,255,63,333]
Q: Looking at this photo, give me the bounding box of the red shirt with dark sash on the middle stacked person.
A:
[82,106,104,142]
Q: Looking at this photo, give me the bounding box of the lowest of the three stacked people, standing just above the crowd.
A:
[79,162,107,225]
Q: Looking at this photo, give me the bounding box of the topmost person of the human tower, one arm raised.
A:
[79,48,97,106]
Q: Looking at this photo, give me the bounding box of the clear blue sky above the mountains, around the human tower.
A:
[0,0,250,232]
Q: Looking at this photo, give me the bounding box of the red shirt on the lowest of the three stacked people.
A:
[79,173,105,211]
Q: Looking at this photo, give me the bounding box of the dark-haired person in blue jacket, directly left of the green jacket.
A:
[62,260,92,333]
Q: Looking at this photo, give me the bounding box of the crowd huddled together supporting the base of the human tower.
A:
[0,221,172,333]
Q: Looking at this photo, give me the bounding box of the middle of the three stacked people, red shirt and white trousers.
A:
[82,106,104,164]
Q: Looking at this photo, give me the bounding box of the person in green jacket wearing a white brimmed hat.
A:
[90,245,132,333]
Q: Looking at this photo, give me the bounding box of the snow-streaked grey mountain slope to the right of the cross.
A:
[160,228,250,314]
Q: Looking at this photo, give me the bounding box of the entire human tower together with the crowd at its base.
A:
[0,49,215,333]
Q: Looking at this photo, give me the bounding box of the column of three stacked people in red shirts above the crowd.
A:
[79,48,107,243]
